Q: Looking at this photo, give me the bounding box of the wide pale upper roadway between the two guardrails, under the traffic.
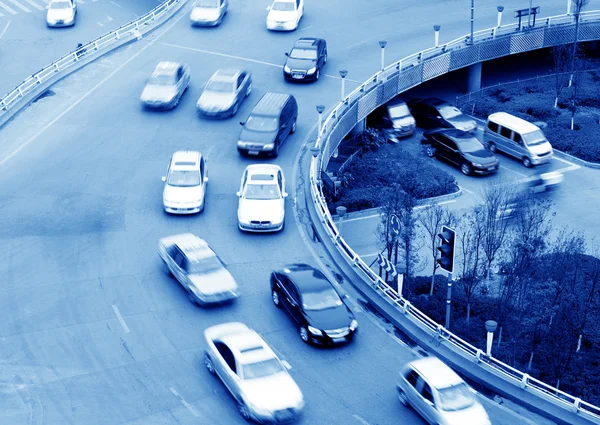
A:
[0,0,584,425]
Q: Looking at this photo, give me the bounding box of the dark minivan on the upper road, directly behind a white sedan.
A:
[237,93,298,156]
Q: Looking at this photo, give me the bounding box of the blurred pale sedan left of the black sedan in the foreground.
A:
[158,233,238,305]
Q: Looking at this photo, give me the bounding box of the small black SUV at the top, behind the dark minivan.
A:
[283,38,327,81]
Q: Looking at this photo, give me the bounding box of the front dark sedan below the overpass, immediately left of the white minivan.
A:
[421,128,500,175]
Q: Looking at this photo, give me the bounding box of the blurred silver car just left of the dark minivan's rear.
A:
[196,69,252,117]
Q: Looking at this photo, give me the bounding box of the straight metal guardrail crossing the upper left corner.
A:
[0,0,181,117]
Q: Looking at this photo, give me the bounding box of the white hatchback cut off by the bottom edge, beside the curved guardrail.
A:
[396,357,491,425]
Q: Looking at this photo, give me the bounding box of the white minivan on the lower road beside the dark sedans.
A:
[484,112,552,167]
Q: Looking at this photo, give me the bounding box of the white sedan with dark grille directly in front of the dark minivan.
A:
[237,164,288,232]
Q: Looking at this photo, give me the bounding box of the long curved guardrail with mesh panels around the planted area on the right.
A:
[309,11,600,422]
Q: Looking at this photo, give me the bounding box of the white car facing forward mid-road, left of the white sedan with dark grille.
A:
[162,151,208,214]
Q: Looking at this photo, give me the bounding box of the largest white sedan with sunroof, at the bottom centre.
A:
[204,322,304,424]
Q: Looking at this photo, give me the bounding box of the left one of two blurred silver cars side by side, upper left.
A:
[140,62,190,109]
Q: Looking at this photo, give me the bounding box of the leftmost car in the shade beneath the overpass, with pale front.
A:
[367,99,416,143]
